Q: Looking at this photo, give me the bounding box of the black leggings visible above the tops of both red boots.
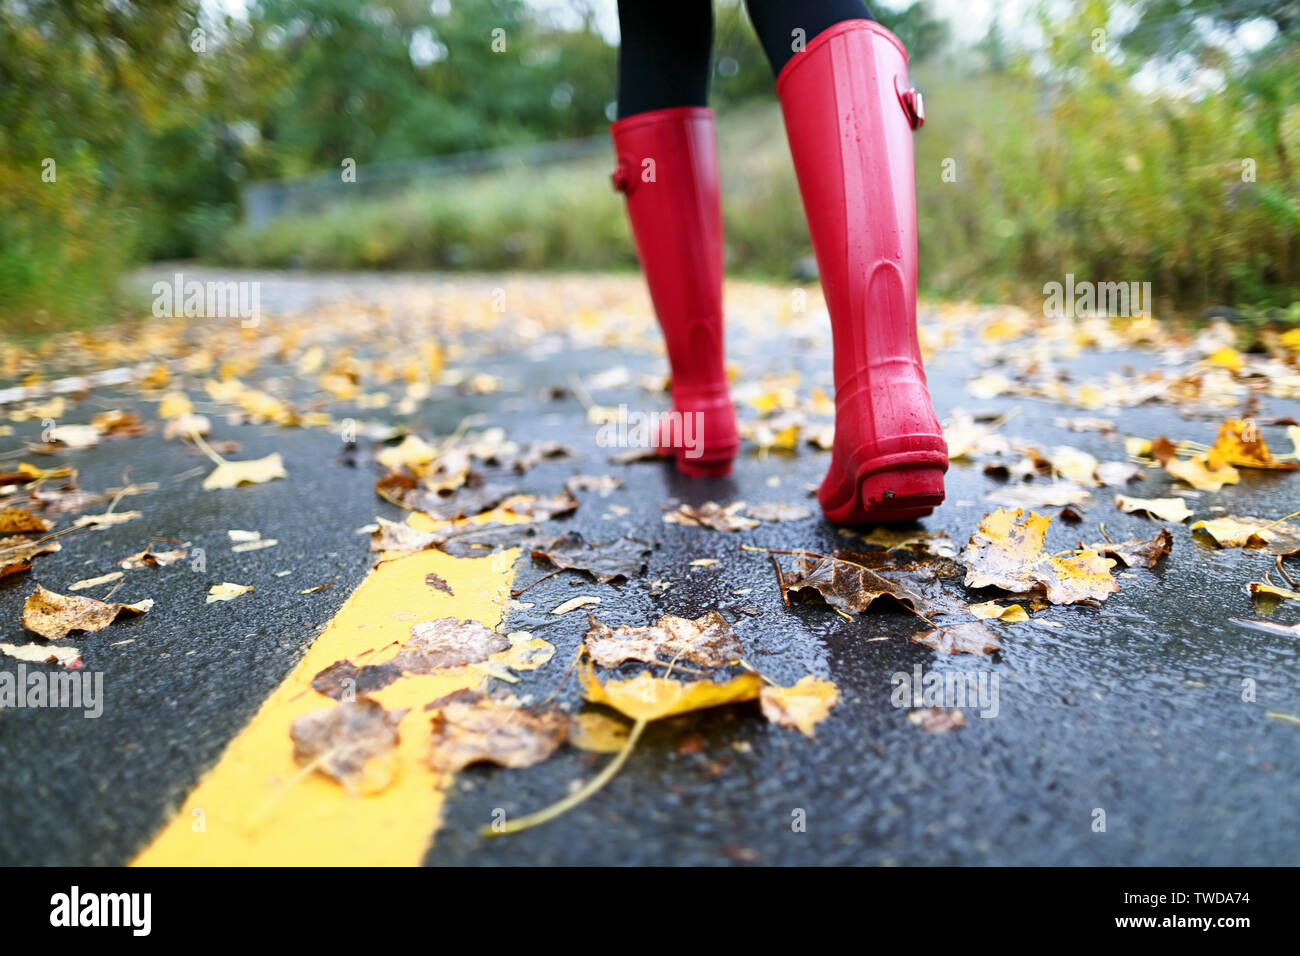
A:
[619,0,872,117]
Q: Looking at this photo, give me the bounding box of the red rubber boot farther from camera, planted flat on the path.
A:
[610,107,740,476]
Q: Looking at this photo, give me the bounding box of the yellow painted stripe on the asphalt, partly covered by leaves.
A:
[133,514,519,866]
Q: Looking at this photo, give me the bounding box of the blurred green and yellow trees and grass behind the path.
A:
[0,0,1300,332]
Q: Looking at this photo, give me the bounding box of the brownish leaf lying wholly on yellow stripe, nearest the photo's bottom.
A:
[289,697,407,795]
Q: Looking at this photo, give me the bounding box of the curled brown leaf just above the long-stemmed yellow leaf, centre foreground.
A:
[582,611,745,667]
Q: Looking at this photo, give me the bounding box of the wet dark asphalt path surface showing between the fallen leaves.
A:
[0,270,1300,865]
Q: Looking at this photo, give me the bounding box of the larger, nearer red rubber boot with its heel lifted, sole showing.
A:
[776,20,948,524]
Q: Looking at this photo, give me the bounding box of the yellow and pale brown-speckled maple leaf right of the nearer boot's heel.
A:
[961,509,1119,604]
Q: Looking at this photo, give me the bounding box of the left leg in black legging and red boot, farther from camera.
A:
[610,0,740,476]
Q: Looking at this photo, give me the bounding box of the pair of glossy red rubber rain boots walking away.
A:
[611,20,948,524]
